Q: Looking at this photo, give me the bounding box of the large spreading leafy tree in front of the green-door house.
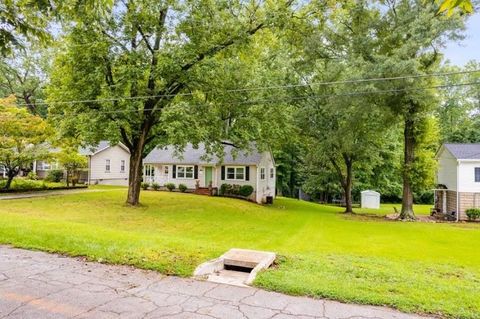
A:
[49,0,289,205]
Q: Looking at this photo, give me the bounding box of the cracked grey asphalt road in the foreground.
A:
[0,246,432,319]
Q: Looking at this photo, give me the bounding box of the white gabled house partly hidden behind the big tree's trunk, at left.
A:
[78,141,130,186]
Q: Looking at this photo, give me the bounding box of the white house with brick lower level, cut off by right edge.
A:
[435,144,480,220]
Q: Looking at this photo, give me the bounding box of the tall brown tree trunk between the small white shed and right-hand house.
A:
[399,112,416,220]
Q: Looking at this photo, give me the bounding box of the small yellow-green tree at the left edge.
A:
[0,97,51,189]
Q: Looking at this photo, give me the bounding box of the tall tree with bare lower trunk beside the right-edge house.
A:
[368,0,464,219]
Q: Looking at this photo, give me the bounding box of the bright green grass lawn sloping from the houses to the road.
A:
[0,189,480,318]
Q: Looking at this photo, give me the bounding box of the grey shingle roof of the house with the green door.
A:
[143,143,262,165]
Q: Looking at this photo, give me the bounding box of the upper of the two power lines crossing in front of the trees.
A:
[13,69,480,106]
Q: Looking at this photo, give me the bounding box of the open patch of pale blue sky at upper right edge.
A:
[444,11,480,66]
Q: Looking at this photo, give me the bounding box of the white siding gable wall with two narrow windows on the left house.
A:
[89,145,130,186]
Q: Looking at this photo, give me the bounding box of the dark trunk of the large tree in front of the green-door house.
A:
[127,142,145,206]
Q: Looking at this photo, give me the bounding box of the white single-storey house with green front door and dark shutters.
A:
[143,144,276,203]
